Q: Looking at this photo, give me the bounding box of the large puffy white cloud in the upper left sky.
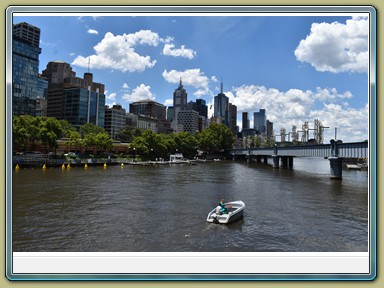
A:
[72,30,160,72]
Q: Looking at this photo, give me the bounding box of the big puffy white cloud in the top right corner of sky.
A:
[295,17,369,73]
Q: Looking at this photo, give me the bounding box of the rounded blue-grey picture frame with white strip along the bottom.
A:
[6,5,377,281]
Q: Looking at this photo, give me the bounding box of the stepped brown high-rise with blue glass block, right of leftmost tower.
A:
[42,61,105,127]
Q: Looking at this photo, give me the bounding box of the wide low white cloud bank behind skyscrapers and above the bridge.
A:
[224,85,368,143]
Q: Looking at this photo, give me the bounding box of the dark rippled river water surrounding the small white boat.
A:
[12,158,368,252]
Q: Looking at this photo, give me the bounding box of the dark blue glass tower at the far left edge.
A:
[12,22,41,116]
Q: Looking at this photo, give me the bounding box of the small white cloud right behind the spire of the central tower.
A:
[163,68,209,90]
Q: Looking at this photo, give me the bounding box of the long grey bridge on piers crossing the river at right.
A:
[230,140,369,179]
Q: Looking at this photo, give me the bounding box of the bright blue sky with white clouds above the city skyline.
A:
[13,13,369,143]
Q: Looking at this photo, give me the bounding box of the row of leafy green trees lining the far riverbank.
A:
[13,115,235,160]
